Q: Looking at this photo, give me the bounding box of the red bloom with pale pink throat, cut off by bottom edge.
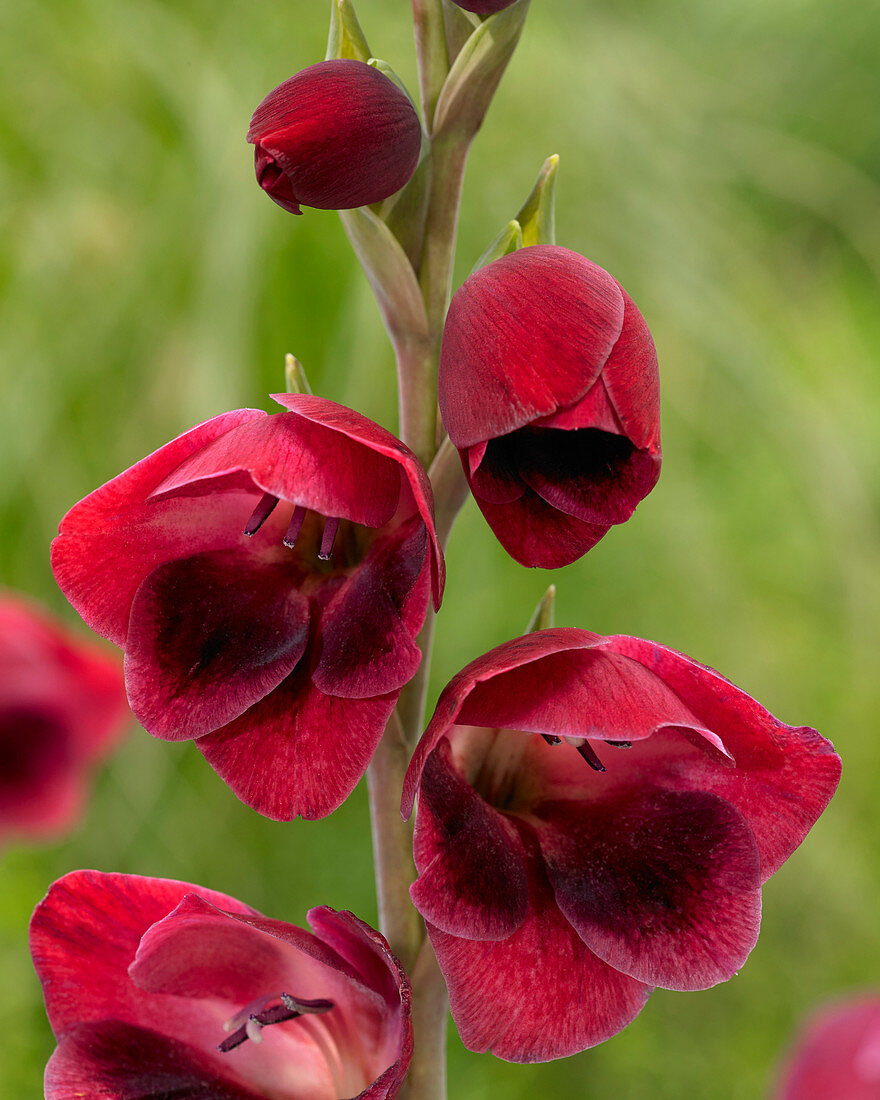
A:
[31,871,413,1100]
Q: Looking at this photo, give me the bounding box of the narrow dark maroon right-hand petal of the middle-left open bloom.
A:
[312,517,429,699]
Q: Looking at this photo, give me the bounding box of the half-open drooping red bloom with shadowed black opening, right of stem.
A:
[440,245,660,569]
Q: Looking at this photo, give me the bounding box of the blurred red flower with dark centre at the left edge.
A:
[0,595,129,838]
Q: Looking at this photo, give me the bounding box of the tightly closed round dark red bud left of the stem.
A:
[248,61,421,213]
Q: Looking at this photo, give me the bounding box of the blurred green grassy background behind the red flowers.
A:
[0,0,880,1100]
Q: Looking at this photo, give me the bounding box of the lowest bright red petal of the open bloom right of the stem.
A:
[428,836,650,1062]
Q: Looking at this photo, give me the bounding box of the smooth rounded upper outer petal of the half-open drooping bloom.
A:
[440,245,624,448]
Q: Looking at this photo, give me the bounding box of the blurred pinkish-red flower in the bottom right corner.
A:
[774,991,880,1100]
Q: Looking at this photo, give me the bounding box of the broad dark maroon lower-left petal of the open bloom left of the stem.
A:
[125,550,309,740]
